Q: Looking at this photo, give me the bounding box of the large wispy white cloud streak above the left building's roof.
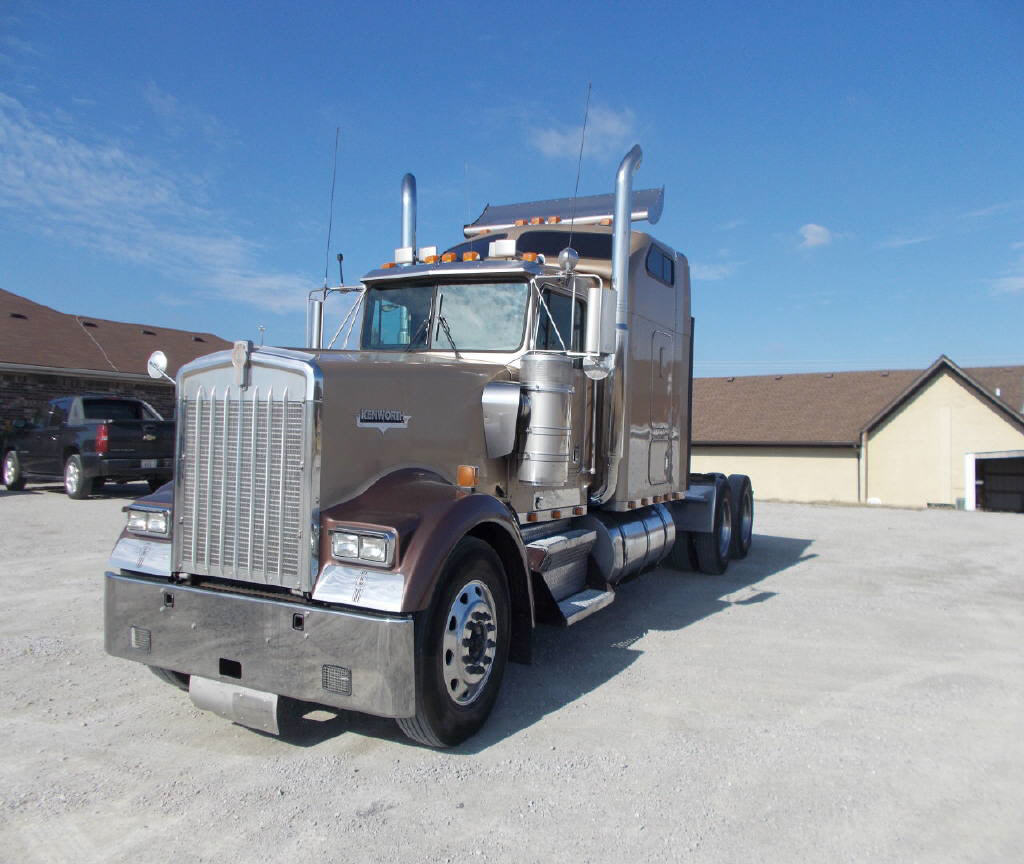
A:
[0,93,315,312]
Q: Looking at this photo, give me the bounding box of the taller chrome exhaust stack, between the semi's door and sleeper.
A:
[591,144,638,506]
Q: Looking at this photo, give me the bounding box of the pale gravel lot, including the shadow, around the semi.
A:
[0,486,1024,864]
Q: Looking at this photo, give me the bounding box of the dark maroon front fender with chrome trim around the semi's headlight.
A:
[313,469,529,613]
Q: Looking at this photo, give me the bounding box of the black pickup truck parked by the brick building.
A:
[0,395,174,499]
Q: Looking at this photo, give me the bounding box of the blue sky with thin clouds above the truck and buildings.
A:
[0,0,1024,375]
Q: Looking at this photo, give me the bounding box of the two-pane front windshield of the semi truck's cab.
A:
[359,282,529,351]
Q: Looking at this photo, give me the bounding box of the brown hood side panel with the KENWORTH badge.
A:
[317,351,511,509]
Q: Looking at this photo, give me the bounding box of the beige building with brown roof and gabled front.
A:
[691,356,1024,512]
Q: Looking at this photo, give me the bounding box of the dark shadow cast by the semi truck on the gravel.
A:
[272,534,817,754]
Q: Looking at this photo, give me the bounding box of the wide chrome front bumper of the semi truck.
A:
[103,571,416,717]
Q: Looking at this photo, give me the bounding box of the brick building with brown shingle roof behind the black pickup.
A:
[0,289,230,425]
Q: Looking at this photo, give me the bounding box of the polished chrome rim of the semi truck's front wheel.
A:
[440,579,498,705]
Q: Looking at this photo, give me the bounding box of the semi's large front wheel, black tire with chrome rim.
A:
[397,537,511,747]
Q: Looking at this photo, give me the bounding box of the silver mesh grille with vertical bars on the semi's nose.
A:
[177,387,306,588]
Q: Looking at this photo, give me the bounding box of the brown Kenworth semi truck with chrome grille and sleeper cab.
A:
[104,146,754,747]
